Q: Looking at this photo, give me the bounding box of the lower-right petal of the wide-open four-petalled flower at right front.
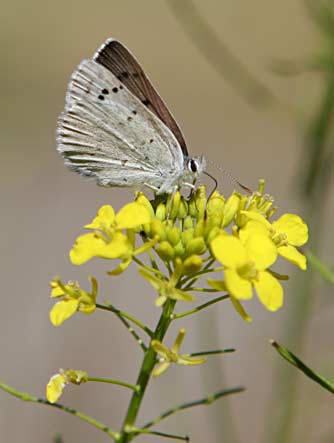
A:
[254,271,283,311]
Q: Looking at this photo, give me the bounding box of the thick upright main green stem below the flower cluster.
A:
[118,300,175,443]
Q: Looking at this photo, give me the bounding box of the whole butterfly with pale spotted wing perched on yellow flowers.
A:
[57,39,206,194]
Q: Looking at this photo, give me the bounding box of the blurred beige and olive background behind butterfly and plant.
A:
[0,0,334,443]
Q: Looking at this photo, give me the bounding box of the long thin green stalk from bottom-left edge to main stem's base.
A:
[0,382,119,441]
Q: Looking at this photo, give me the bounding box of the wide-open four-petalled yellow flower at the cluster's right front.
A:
[211,231,283,311]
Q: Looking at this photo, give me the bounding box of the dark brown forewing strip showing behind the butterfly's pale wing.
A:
[94,39,188,157]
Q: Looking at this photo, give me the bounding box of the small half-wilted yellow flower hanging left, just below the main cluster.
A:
[50,277,97,326]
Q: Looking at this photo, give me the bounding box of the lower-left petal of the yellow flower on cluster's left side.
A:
[70,232,105,265]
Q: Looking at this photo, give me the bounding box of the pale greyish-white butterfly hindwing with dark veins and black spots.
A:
[57,60,184,192]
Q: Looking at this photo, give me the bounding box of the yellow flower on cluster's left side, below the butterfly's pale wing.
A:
[70,202,154,273]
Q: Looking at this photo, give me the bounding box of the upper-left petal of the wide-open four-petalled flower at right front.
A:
[211,234,248,269]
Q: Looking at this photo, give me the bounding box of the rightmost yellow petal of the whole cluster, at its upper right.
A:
[273,214,308,246]
